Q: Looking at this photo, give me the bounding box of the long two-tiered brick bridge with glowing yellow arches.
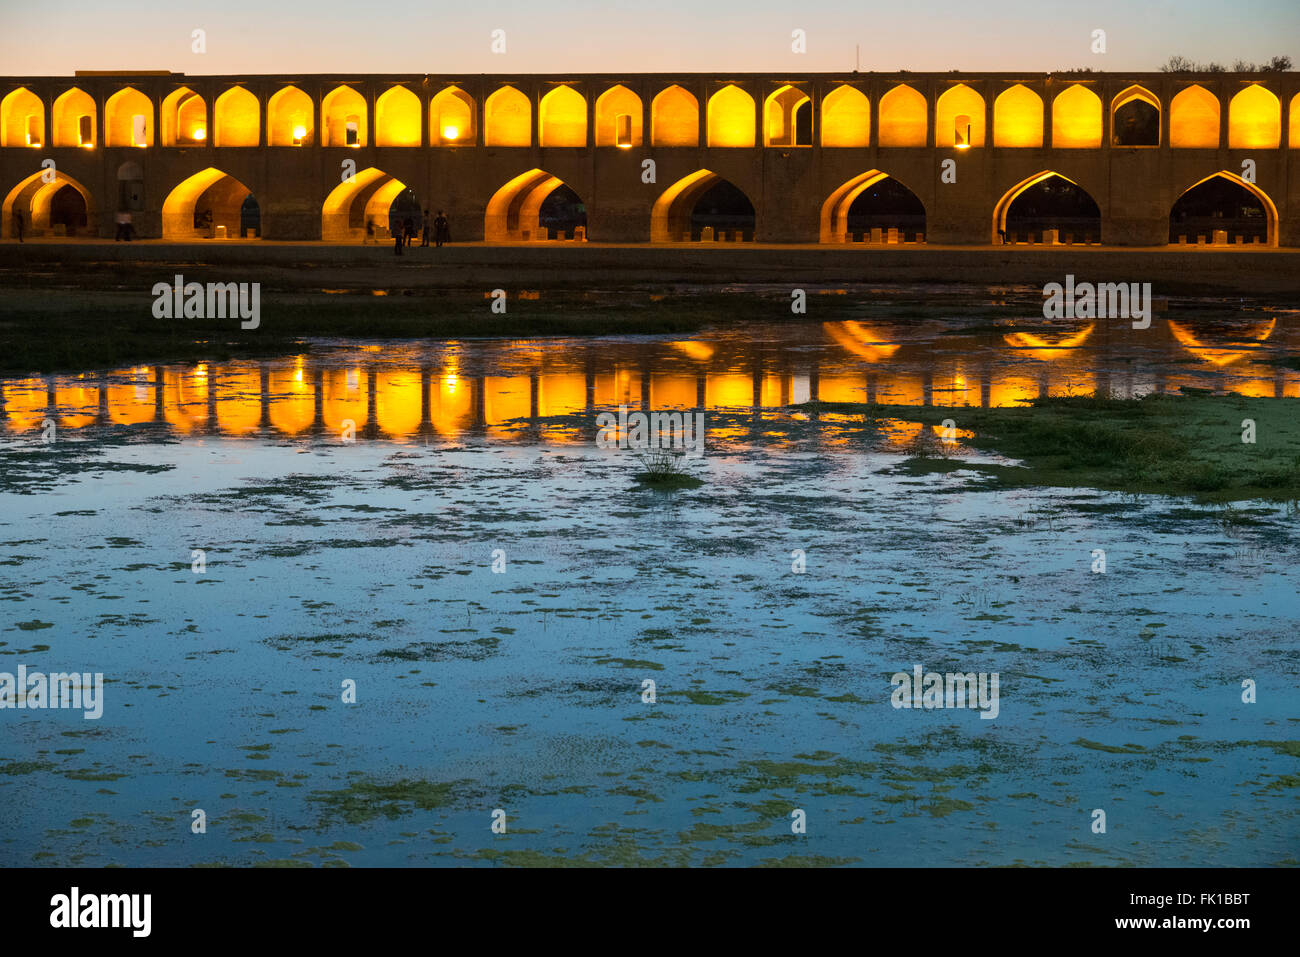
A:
[0,72,1300,246]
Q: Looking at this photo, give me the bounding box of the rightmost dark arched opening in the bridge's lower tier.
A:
[1169,172,1278,246]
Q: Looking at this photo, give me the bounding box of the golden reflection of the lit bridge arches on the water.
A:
[0,317,1300,442]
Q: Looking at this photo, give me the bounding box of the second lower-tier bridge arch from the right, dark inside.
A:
[992,170,1101,246]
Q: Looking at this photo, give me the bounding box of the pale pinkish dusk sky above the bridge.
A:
[0,0,1300,75]
